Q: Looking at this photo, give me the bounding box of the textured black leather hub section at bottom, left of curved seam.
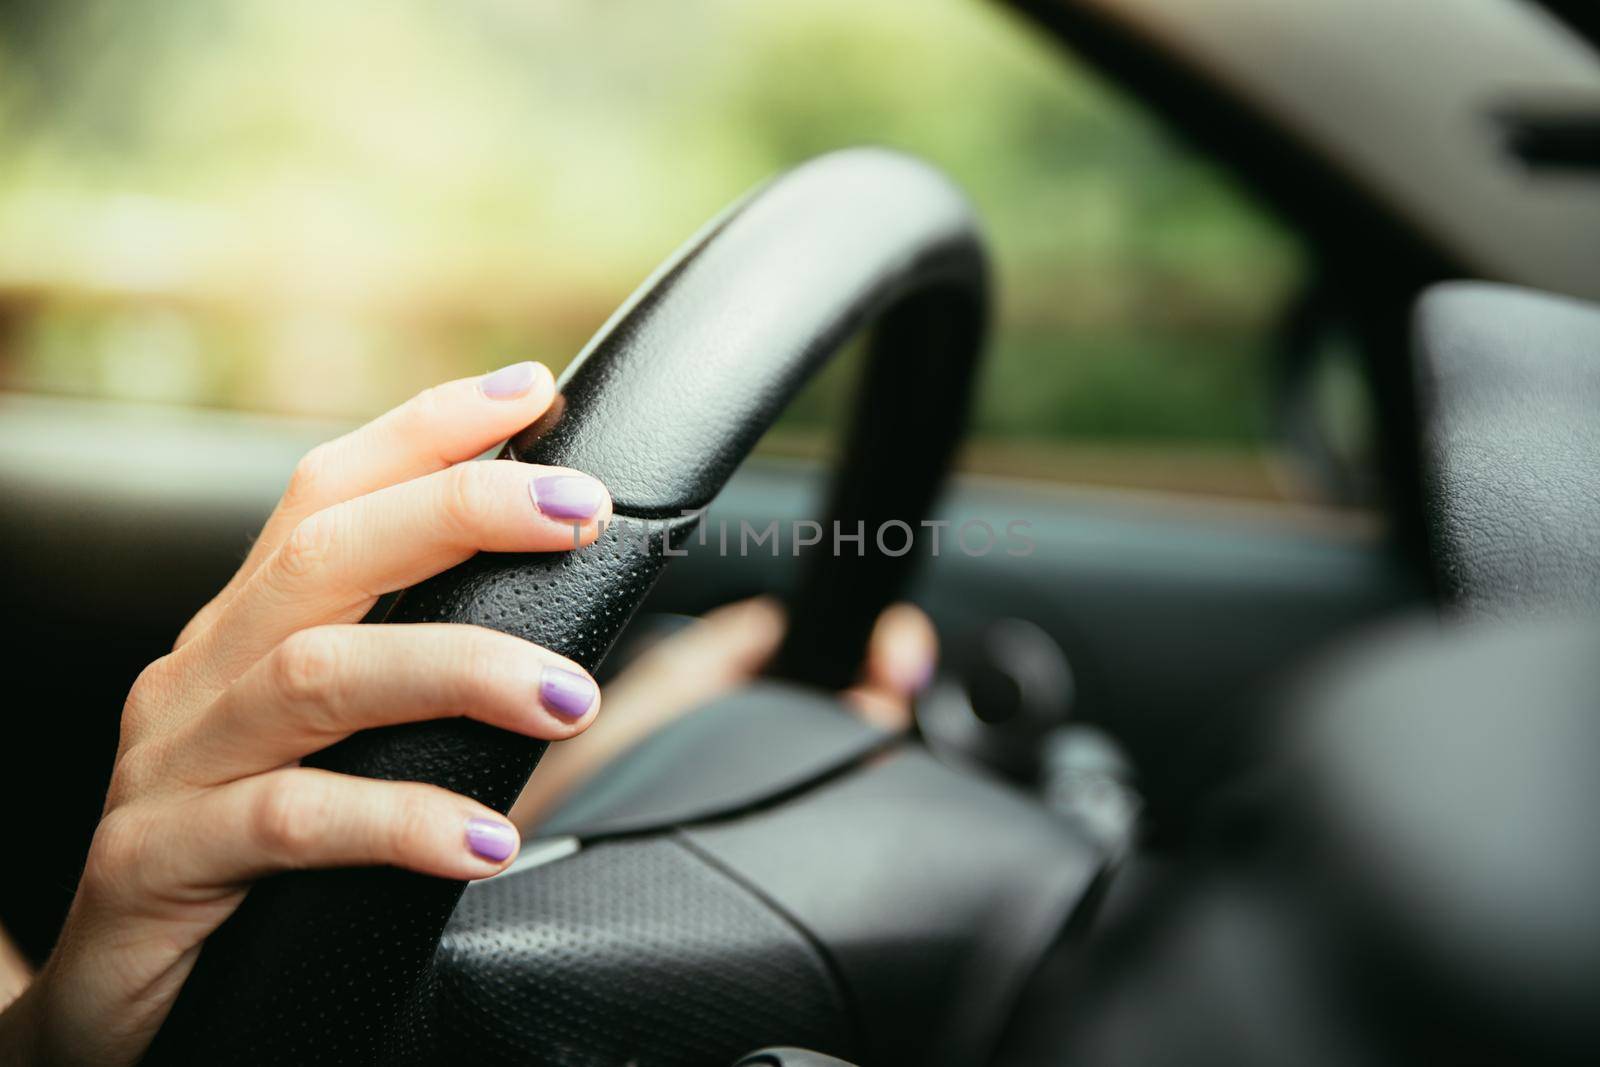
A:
[422,835,858,1067]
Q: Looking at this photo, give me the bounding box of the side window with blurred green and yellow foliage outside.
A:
[0,0,1304,499]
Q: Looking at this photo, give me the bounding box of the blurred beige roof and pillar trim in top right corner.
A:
[1013,0,1600,303]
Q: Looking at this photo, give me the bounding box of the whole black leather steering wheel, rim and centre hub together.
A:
[150,149,1098,1065]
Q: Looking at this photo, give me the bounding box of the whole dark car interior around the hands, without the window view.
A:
[0,0,1600,1067]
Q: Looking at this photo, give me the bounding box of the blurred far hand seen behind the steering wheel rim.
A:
[510,597,939,832]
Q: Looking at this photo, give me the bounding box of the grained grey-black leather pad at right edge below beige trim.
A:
[1414,282,1600,616]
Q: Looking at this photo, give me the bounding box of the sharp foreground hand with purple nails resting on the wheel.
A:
[0,363,611,1064]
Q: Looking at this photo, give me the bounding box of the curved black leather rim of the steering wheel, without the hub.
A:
[152,149,987,1062]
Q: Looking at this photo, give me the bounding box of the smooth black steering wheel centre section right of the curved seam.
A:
[680,744,1106,1067]
